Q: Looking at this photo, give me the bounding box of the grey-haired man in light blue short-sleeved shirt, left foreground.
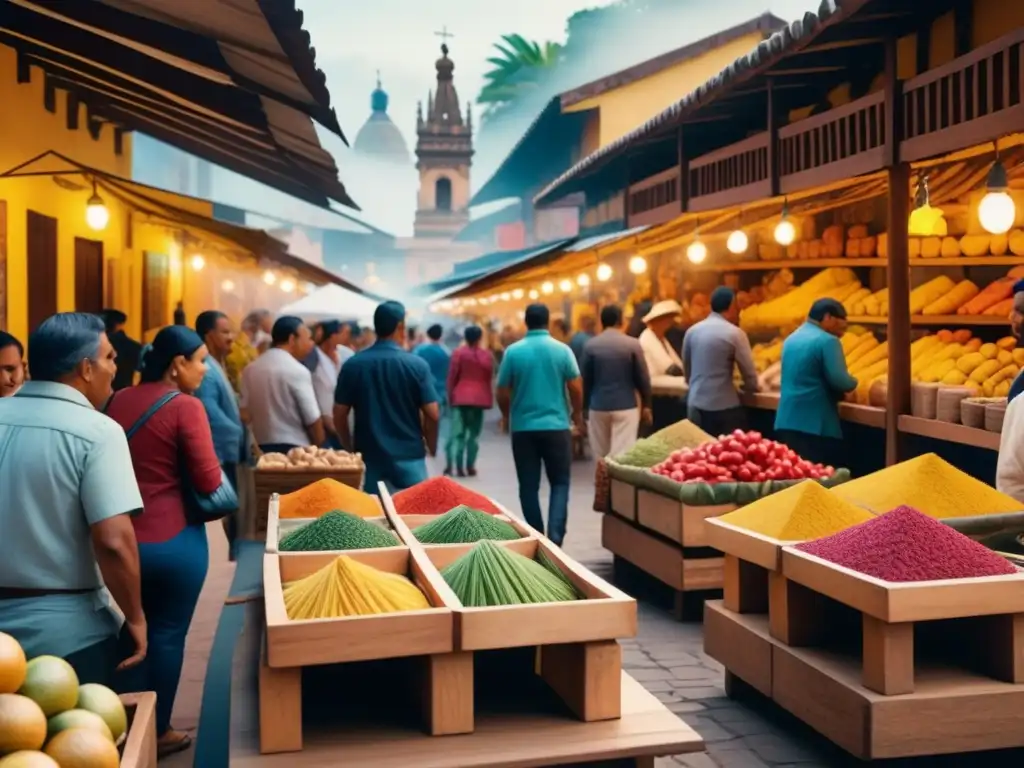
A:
[0,312,146,684]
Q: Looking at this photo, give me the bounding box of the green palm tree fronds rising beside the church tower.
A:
[476,34,562,120]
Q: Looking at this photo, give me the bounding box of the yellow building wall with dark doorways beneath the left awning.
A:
[0,45,138,339]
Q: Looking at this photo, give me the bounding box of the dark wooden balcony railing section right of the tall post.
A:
[900,28,1024,162]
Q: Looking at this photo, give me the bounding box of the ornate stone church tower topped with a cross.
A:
[414,43,473,240]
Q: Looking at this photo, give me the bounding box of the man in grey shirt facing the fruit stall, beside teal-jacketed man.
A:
[683,287,758,436]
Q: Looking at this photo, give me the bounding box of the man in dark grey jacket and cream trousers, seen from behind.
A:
[581,305,651,459]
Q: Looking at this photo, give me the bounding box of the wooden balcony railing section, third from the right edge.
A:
[687,131,771,211]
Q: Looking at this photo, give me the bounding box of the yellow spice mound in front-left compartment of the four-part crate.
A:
[285,555,430,620]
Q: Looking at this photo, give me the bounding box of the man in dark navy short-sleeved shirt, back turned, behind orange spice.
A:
[334,301,440,494]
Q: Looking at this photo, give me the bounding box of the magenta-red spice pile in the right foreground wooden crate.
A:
[797,507,1018,582]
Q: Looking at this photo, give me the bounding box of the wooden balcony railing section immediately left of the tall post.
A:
[778,91,887,194]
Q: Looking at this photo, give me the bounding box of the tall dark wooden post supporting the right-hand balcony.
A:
[885,38,910,465]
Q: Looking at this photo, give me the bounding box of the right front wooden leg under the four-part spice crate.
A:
[541,640,623,723]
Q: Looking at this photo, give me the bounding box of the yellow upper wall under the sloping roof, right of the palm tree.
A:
[565,32,763,148]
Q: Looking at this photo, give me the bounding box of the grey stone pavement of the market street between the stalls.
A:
[161,418,929,768]
